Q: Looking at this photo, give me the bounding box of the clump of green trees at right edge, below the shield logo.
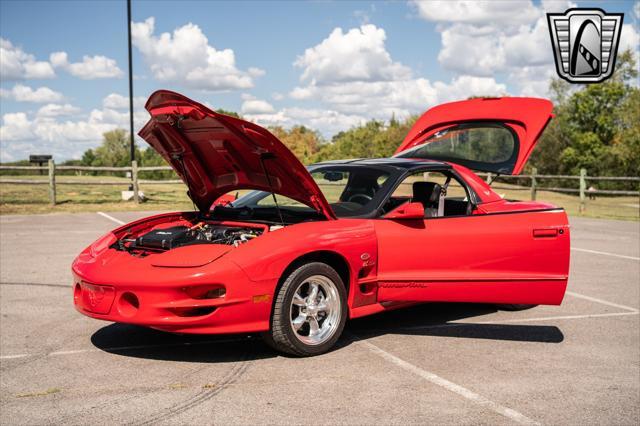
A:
[530,51,640,180]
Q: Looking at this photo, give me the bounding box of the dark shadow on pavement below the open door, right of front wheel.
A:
[347,303,564,343]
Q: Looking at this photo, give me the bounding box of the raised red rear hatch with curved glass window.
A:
[395,97,553,174]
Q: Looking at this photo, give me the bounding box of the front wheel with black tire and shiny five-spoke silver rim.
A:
[264,262,347,356]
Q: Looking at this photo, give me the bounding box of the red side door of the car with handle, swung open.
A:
[375,210,569,304]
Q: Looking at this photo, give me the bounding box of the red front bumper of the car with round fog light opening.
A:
[73,255,276,334]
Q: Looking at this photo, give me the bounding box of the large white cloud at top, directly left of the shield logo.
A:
[414,0,575,96]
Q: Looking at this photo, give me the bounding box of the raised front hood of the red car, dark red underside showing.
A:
[139,90,335,218]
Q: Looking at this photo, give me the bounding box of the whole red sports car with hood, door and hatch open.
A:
[73,90,569,356]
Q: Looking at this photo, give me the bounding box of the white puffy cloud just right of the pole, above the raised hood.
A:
[131,17,264,91]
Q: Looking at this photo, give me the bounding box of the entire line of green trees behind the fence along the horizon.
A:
[2,50,640,185]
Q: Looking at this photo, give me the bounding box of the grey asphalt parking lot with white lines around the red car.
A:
[0,213,640,425]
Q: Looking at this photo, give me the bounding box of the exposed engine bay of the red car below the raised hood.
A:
[111,221,269,256]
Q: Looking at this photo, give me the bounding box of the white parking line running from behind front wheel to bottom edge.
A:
[359,340,539,425]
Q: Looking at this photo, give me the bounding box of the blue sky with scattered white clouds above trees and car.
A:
[0,0,639,161]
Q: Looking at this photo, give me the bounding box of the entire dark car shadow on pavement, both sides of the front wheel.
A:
[91,303,564,363]
